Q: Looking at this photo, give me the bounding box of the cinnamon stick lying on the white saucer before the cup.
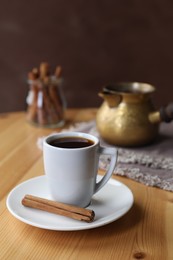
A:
[22,195,95,222]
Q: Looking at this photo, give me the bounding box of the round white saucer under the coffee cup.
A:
[6,175,134,231]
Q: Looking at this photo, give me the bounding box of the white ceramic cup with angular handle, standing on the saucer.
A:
[43,132,117,207]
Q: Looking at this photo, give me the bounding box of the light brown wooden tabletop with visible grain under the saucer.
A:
[0,109,173,260]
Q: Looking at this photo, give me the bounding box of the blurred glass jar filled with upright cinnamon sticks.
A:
[27,62,65,126]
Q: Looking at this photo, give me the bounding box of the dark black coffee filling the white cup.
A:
[49,136,94,149]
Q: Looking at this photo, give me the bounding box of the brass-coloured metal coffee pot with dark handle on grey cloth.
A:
[96,82,173,146]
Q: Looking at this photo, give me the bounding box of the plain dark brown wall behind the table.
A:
[0,0,173,112]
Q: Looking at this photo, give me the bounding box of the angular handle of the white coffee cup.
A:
[94,146,118,194]
